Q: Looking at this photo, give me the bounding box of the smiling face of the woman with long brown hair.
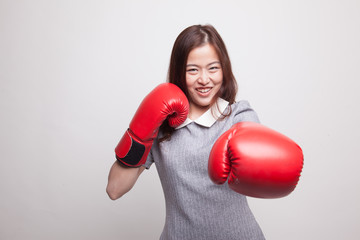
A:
[186,43,223,119]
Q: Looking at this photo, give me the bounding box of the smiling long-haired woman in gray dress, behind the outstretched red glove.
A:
[107,25,264,240]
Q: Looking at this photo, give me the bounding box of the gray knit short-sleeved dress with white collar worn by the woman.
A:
[144,99,265,240]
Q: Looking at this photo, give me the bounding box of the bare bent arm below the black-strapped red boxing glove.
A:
[106,161,145,200]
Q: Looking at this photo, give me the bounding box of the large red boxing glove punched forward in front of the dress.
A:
[208,122,304,198]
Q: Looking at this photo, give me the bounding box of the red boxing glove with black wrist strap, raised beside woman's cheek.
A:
[115,83,189,167]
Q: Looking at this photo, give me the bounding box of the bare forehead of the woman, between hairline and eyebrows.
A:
[187,43,219,64]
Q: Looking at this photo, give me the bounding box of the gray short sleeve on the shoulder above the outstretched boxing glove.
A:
[232,100,260,124]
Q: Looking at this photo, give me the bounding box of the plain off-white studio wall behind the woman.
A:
[0,0,360,240]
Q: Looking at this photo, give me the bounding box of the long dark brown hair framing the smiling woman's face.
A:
[160,25,237,142]
